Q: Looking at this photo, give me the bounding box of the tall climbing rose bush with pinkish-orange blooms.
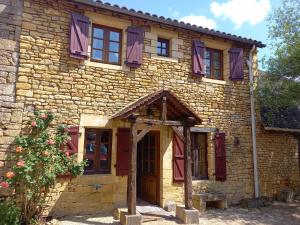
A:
[0,112,85,224]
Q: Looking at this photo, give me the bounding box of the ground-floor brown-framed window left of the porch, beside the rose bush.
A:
[84,129,112,174]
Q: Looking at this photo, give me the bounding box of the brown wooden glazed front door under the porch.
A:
[137,131,159,204]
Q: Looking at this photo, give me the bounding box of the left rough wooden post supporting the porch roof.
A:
[127,115,137,215]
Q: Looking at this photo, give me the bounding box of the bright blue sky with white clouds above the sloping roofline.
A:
[104,0,281,68]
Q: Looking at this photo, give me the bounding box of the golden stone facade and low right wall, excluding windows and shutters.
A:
[0,0,299,218]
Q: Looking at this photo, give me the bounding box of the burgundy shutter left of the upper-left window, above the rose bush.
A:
[69,12,89,59]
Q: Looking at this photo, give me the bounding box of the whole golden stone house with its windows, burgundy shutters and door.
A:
[0,0,300,219]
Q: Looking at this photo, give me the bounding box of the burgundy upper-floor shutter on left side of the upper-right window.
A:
[192,40,205,75]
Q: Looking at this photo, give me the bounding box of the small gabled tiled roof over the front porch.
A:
[112,90,201,124]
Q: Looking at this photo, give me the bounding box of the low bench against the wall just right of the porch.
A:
[193,192,227,212]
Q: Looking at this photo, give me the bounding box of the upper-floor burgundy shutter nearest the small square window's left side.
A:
[125,27,144,68]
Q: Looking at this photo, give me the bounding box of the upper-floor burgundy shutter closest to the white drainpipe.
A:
[229,48,244,80]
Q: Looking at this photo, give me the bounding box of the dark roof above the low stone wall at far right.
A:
[261,108,300,131]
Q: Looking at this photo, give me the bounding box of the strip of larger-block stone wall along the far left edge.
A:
[0,0,23,174]
